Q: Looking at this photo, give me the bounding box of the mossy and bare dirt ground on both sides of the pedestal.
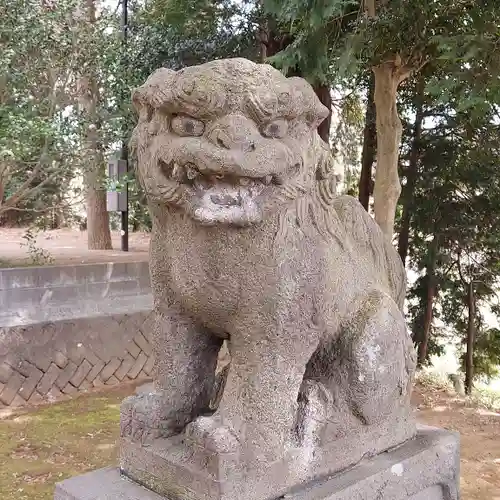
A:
[0,380,500,500]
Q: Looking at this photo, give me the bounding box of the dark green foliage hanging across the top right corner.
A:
[263,0,500,94]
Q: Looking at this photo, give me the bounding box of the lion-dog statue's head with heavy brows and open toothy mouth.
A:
[131,59,335,226]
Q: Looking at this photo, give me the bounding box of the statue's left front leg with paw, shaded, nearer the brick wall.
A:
[120,308,222,443]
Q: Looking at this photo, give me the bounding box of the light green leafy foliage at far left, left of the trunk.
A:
[0,0,80,219]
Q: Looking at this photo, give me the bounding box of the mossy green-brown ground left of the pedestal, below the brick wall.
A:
[0,388,132,500]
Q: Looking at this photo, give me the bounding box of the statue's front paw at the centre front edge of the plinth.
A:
[185,415,239,453]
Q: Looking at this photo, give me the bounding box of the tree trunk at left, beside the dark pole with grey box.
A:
[78,0,112,250]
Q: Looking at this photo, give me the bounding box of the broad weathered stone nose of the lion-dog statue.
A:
[208,115,259,152]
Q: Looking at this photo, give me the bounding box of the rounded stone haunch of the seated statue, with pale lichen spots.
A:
[334,292,415,425]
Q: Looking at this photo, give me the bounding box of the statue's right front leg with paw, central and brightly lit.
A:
[186,316,320,462]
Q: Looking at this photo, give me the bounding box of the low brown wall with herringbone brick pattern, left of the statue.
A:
[0,311,153,408]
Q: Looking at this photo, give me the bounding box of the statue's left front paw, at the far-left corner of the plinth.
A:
[120,393,179,445]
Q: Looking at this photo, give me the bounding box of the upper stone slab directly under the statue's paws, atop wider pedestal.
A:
[120,417,416,500]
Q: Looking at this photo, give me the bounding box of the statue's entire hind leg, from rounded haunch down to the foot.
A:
[297,291,415,444]
